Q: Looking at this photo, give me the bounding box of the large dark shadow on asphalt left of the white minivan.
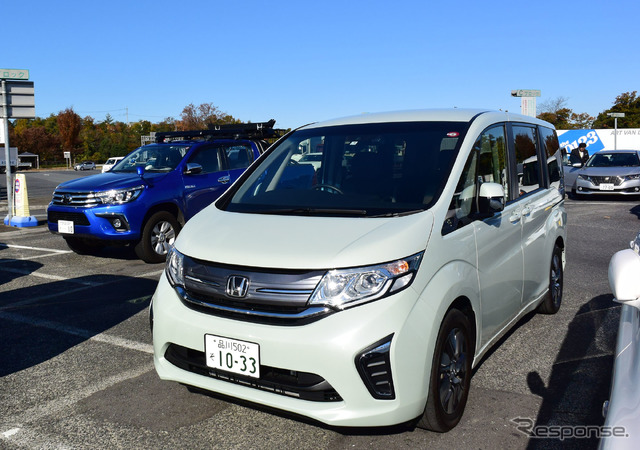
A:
[0,274,158,377]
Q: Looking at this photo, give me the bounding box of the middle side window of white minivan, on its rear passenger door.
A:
[513,125,541,196]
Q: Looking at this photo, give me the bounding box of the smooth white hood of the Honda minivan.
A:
[175,205,433,269]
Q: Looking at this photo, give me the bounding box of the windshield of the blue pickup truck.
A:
[111,144,190,172]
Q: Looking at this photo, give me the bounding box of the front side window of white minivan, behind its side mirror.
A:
[442,125,509,235]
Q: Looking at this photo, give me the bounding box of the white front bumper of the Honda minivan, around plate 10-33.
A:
[152,274,434,426]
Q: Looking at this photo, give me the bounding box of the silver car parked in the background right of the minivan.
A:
[565,150,640,195]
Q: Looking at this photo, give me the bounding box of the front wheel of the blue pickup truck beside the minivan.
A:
[135,211,180,263]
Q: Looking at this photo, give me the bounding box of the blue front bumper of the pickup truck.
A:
[47,204,142,241]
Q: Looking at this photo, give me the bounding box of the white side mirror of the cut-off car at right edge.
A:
[609,249,640,309]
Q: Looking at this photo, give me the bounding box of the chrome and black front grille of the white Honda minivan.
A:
[175,256,334,325]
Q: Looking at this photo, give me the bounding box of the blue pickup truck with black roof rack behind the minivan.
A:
[47,120,280,263]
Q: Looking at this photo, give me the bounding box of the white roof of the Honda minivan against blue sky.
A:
[302,108,550,129]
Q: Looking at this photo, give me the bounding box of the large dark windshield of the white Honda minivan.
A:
[221,122,467,217]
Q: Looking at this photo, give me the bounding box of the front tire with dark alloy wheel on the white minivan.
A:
[418,309,474,433]
